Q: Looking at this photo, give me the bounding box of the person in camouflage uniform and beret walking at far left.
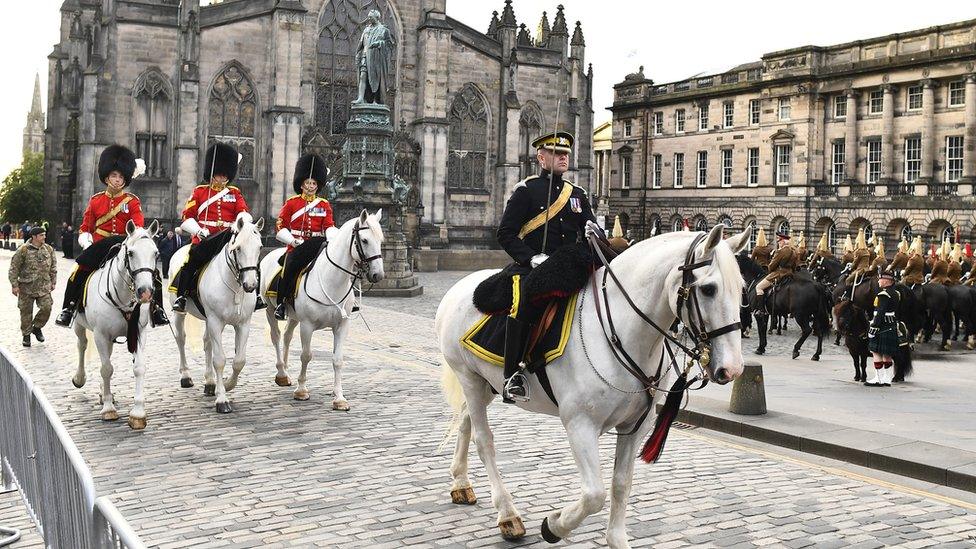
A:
[7,227,58,347]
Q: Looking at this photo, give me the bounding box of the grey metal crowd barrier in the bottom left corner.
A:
[0,349,144,549]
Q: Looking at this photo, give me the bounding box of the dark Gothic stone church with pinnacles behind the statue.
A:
[45,0,593,247]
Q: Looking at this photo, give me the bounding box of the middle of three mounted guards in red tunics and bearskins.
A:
[173,143,265,313]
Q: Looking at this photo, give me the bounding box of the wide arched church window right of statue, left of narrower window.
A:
[447,84,488,189]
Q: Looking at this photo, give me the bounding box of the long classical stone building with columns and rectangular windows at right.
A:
[610,20,976,249]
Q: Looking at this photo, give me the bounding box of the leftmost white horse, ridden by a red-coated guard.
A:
[71,220,159,429]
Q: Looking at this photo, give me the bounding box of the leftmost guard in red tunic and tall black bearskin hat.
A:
[54,145,169,326]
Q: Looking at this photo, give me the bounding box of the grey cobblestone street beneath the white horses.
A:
[0,255,976,549]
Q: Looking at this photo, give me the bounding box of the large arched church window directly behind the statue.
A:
[315,0,399,135]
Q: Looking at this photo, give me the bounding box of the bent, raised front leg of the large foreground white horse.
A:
[542,419,608,543]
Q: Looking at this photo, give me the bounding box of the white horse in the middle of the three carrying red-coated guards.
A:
[169,212,264,414]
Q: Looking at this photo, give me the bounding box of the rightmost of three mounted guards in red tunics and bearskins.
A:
[275,154,335,320]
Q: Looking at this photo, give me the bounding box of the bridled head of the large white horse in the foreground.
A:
[667,225,749,384]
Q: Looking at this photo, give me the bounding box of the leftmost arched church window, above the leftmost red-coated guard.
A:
[132,70,172,178]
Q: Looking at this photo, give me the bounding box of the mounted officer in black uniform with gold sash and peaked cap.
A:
[497,132,596,402]
